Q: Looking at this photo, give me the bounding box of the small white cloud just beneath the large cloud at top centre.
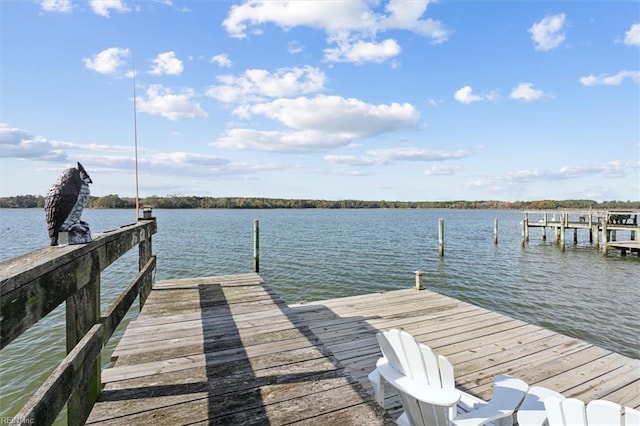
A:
[324,39,402,64]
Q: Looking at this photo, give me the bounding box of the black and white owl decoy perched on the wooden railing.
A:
[44,162,93,246]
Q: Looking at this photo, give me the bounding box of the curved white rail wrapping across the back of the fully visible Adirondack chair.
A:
[377,361,460,407]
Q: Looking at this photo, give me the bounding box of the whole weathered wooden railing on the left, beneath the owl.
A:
[0,216,157,425]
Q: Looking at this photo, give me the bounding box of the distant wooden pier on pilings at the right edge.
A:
[522,210,640,256]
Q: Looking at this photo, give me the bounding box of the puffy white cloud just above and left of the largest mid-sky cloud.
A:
[206,66,327,103]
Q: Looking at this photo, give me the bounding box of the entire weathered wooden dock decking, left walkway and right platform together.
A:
[87,274,640,425]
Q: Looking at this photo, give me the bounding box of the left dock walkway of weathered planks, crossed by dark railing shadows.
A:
[87,274,393,425]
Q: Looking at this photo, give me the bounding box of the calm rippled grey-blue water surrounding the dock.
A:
[0,209,640,416]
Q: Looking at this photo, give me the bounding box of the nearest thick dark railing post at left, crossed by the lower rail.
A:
[66,251,102,426]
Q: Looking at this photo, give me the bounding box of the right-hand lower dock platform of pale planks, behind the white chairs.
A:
[291,289,640,411]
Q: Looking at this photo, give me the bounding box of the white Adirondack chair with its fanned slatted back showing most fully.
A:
[369,329,528,426]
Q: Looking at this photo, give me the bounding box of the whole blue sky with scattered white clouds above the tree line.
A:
[0,0,640,201]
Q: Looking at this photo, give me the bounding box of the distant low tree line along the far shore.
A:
[0,194,640,210]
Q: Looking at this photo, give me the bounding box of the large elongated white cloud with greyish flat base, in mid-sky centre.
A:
[243,95,420,138]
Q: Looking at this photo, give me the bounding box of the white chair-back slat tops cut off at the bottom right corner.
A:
[544,398,640,426]
